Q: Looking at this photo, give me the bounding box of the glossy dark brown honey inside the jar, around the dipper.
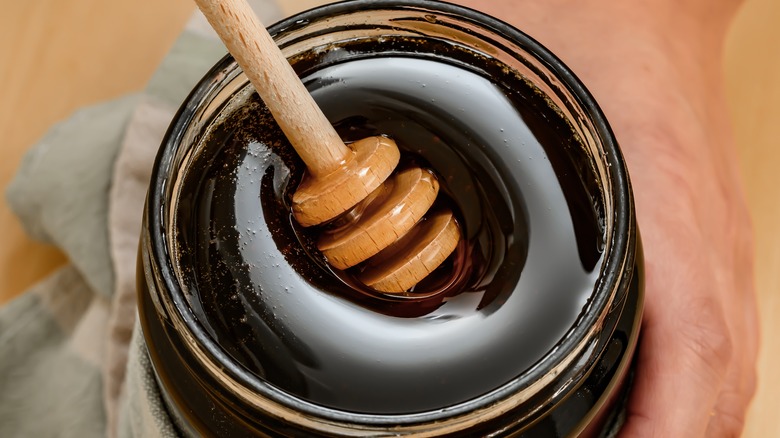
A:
[175,47,604,414]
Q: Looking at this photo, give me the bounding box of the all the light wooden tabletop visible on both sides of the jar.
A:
[0,0,780,432]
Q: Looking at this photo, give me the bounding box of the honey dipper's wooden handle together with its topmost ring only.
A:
[195,0,400,227]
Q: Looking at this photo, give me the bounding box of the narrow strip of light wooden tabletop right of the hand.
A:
[726,0,780,438]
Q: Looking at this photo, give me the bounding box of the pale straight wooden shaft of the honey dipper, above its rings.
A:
[195,0,352,177]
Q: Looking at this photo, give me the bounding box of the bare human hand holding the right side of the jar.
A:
[460,0,758,438]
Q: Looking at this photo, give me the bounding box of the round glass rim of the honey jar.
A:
[146,0,636,425]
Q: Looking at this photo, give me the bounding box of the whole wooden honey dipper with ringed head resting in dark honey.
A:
[195,0,460,293]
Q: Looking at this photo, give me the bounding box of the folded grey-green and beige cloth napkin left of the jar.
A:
[0,0,280,438]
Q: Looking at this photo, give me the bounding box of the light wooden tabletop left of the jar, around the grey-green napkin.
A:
[0,0,195,303]
